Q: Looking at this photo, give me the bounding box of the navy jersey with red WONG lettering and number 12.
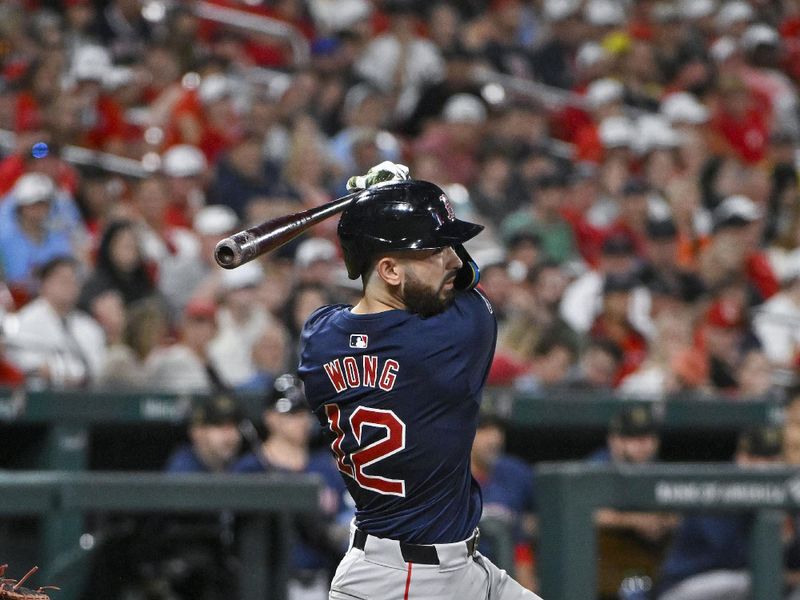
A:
[299,290,497,544]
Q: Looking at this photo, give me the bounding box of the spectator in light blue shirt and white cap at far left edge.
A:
[0,173,74,293]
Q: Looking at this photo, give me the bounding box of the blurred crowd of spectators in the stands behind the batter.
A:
[0,0,800,399]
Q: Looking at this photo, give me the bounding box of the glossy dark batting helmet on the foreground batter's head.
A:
[339,179,483,279]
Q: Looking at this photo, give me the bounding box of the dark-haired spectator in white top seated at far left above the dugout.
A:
[6,257,106,388]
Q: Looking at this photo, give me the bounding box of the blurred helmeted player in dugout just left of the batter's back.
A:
[232,373,353,600]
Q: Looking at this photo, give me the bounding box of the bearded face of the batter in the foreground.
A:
[402,247,461,317]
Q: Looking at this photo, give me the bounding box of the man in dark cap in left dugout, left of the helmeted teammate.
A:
[164,394,244,473]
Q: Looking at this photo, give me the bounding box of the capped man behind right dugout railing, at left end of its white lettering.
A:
[587,404,675,598]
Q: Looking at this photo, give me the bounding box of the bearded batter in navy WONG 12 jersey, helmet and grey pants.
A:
[299,168,538,600]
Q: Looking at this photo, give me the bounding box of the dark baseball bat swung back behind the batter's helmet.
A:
[214,190,362,269]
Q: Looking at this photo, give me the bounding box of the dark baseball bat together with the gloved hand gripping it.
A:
[214,161,409,269]
